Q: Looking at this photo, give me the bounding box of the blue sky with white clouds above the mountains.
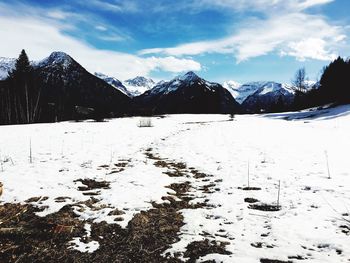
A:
[0,0,350,83]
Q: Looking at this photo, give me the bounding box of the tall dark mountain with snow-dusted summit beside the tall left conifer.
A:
[35,52,130,120]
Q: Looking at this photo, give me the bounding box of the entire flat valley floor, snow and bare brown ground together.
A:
[0,106,350,262]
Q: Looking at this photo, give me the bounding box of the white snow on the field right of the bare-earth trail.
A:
[158,107,350,262]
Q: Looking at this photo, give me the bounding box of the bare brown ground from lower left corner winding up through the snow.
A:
[0,149,229,263]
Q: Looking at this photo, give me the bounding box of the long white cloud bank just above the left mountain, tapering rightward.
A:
[0,10,201,80]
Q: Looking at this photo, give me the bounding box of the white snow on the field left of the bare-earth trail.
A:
[0,118,183,226]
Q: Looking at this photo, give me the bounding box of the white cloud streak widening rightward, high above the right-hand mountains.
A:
[140,9,346,62]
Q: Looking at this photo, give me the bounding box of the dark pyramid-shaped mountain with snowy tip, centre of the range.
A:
[134,72,240,114]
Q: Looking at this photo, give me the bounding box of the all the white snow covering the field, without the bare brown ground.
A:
[0,106,350,262]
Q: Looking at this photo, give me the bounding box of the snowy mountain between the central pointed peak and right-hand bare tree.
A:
[242,81,294,112]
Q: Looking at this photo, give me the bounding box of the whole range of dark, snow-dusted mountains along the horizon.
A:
[0,52,315,122]
